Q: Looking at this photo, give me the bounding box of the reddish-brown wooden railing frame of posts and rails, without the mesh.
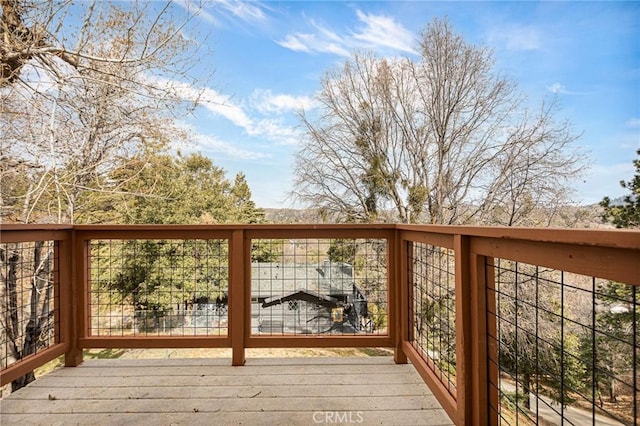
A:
[0,224,640,425]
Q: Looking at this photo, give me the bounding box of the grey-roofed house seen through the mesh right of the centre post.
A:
[251,261,371,334]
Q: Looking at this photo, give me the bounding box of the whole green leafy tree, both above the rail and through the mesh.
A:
[92,150,264,324]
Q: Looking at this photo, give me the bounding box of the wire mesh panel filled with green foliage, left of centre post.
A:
[89,239,229,336]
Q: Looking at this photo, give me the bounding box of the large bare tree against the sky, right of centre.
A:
[294,20,584,225]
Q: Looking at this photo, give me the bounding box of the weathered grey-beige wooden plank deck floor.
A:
[0,357,452,426]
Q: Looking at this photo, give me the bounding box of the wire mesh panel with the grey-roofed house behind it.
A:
[251,239,388,335]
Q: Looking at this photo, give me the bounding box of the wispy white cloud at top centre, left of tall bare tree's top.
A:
[276,10,416,56]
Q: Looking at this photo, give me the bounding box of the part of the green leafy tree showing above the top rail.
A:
[112,154,264,224]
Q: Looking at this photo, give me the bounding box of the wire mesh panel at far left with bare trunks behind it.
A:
[0,241,60,368]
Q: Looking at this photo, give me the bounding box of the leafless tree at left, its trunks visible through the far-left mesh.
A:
[0,0,208,389]
